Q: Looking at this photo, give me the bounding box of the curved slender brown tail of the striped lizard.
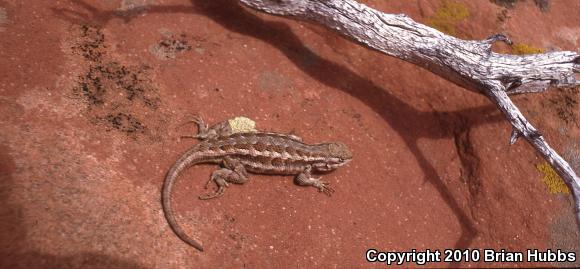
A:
[161,148,203,251]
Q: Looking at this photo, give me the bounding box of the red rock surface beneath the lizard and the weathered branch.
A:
[0,0,580,268]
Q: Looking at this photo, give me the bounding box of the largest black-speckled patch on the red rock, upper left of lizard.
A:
[72,25,161,134]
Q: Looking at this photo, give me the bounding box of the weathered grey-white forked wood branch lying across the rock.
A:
[240,0,580,227]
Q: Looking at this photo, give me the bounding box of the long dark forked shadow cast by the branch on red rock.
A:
[53,0,510,251]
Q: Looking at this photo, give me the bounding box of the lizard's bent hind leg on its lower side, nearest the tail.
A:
[199,157,248,200]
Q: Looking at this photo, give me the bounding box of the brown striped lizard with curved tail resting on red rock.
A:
[161,116,352,251]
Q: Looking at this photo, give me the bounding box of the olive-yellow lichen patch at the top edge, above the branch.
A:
[427,0,469,35]
